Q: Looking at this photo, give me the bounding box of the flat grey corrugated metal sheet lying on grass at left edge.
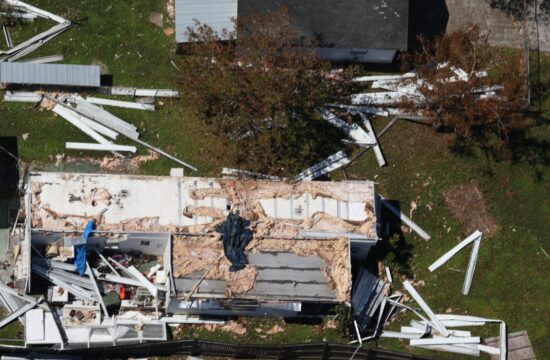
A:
[0,62,101,87]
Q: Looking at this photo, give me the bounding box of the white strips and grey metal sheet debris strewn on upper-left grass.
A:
[0,0,197,171]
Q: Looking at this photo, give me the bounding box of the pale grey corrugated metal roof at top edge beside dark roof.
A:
[176,0,238,43]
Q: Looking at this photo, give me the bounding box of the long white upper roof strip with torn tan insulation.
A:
[31,173,377,239]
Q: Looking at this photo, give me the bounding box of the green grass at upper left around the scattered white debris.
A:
[0,0,223,175]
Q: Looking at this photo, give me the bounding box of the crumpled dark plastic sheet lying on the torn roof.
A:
[216,212,252,272]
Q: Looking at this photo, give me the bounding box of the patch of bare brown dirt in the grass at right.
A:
[443,181,497,236]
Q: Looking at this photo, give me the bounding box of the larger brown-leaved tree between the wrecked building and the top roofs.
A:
[181,9,353,174]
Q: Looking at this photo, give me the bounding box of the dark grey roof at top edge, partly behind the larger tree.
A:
[238,0,409,50]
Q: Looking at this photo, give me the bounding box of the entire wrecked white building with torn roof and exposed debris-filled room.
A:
[7,172,381,346]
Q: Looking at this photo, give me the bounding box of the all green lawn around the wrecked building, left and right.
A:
[0,0,550,358]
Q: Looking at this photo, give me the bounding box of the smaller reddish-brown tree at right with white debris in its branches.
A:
[402,27,527,140]
